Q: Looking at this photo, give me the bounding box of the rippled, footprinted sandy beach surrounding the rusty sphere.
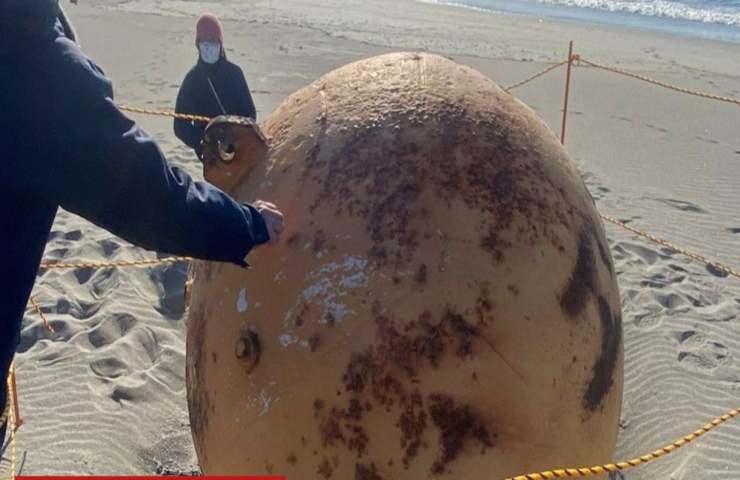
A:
[7,0,740,480]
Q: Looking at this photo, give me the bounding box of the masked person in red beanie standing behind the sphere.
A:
[175,14,257,157]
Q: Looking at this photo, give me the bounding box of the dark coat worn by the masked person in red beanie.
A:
[175,56,257,148]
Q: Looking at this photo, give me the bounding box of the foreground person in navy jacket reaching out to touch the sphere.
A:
[0,0,283,446]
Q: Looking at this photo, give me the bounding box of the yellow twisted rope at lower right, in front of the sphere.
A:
[506,409,740,480]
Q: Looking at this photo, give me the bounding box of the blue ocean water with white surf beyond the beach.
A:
[418,0,740,41]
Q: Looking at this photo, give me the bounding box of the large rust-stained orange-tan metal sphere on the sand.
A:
[187,53,623,480]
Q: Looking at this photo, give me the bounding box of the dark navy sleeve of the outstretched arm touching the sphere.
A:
[46,46,268,265]
